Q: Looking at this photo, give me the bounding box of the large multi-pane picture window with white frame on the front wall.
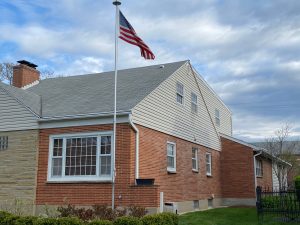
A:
[48,132,112,182]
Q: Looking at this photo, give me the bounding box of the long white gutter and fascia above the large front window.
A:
[38,111,131,122]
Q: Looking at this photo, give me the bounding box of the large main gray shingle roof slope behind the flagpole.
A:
[27,61,187,117]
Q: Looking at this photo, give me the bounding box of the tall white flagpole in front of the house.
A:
[111,0,121,209]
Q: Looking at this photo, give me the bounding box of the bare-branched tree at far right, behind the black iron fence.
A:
[264,124,299,189]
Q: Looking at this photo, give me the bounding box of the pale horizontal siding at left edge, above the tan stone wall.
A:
[0,89,38,131]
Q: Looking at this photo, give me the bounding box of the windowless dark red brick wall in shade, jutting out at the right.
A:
[221,137,255,198]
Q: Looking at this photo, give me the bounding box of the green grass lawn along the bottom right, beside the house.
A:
[179,208,299,225]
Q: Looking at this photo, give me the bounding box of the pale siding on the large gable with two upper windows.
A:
[133,63,221,150]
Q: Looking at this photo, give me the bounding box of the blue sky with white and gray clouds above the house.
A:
[0,0,300,141]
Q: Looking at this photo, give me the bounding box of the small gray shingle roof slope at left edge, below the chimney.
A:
[0,82,41,115]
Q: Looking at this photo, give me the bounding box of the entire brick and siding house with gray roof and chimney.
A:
[0,61,284,214]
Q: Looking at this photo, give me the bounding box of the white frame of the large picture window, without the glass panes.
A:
[47,131,113,183]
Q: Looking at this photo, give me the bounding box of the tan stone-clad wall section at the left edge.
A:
[0,130,39,215]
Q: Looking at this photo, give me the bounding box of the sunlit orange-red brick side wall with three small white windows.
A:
[138,126,221,202]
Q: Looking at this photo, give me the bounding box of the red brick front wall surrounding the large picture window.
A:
[36,124,159,207]
